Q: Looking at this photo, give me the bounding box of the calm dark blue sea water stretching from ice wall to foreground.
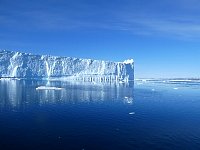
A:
[0,80,200,150]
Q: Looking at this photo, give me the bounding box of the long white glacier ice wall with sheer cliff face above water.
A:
[0,50,134,81]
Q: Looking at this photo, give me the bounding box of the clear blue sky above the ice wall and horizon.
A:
[0,0,200,78]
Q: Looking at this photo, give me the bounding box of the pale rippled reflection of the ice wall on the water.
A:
[0,80,134,109]
